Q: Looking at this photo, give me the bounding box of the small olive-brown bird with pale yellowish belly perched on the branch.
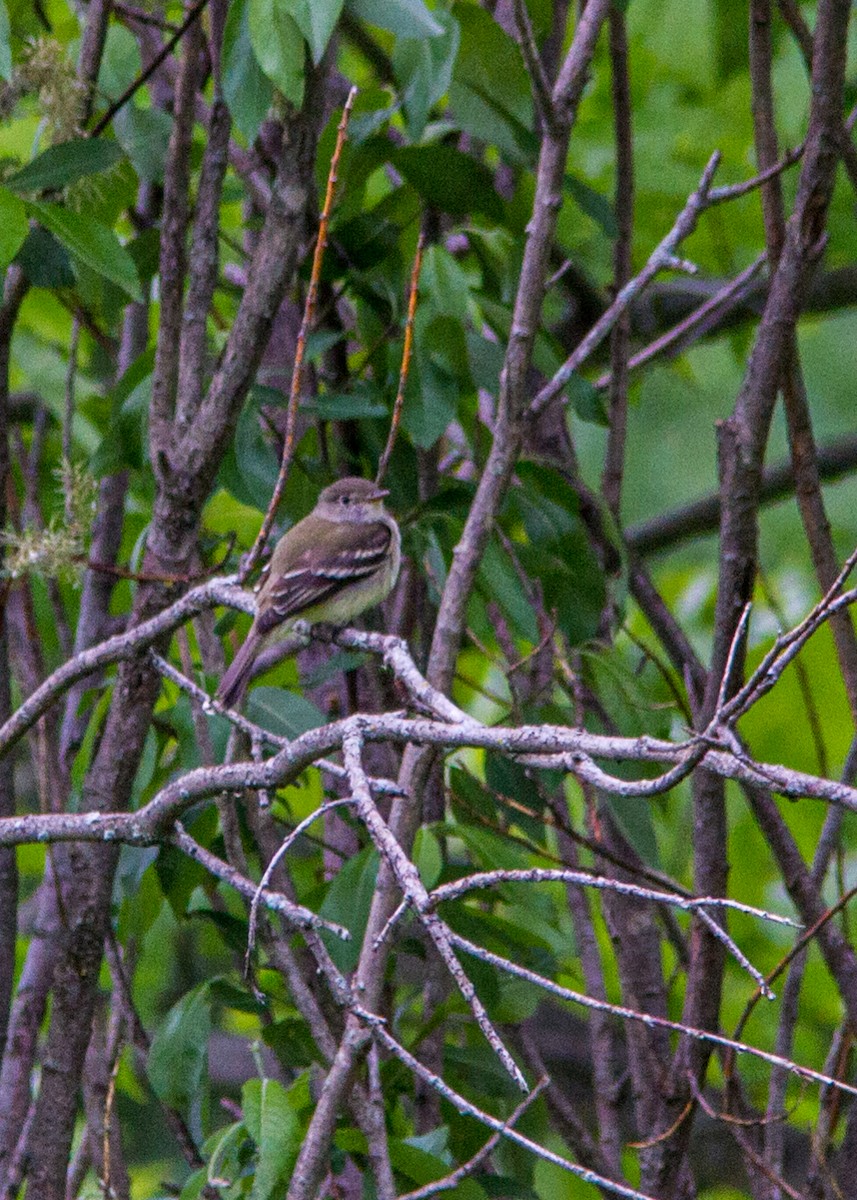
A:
[217,476,402,708]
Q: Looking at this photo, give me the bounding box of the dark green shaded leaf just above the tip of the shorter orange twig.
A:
[391,143,503,221]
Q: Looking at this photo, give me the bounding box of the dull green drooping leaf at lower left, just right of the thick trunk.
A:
[146,983,211,1110]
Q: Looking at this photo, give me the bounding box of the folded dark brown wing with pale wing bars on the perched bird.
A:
[256,521,392,637]
